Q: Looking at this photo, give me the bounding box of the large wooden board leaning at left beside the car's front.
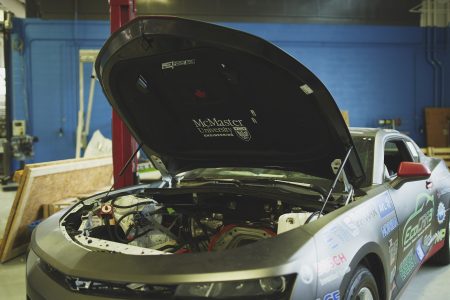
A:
[0,157,112,262]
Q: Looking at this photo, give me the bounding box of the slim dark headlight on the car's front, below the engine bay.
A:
[175,275,294,299]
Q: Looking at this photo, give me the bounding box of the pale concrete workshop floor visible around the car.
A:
[0,190,450,300]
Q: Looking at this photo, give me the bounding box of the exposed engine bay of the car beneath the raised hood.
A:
[61,190,319,255]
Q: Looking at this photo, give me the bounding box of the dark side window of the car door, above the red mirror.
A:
[384,140,417,177]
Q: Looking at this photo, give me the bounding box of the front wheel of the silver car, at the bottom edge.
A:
[344,266,380,300]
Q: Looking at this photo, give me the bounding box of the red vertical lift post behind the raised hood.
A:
[109,0,137,189]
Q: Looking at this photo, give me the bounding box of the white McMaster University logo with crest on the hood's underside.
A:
[192,118,252,142]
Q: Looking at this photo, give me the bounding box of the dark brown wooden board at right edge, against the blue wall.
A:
[425,108,450,147]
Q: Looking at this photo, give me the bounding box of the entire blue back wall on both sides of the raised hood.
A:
[8,19,450,161]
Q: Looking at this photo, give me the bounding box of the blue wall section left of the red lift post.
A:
[12,19,111,162]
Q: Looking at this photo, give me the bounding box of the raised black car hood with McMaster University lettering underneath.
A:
[96,16,364,185]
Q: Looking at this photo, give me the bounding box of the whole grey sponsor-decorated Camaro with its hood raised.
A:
[27,17,450,300]
